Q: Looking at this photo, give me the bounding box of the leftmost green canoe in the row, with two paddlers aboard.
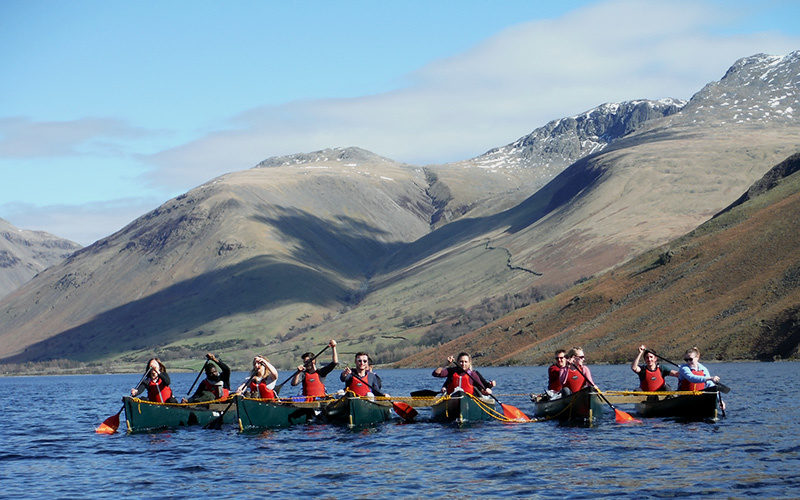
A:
[122,396,236,432]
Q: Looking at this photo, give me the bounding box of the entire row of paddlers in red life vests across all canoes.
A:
[126,339,724,410]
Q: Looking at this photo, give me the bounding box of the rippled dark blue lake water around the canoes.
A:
[0,362,800,498]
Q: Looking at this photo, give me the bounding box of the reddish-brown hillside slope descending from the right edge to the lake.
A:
[398,155,800,366]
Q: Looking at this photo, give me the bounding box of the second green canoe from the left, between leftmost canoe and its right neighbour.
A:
[236,396,320,431]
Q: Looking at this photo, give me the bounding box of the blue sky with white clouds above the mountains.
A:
[0,0,800,245]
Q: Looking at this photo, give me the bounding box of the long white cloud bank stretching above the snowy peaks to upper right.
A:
[143,1,800,188]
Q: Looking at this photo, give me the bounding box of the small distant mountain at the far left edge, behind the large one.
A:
[0,219,81,298]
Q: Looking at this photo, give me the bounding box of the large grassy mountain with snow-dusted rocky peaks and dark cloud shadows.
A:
[0,53,800,370]
